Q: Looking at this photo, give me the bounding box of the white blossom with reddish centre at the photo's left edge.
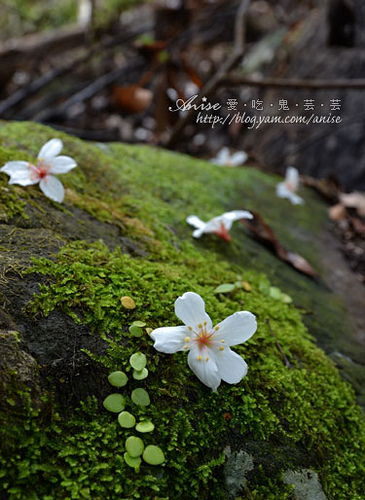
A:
[0,139,77,203]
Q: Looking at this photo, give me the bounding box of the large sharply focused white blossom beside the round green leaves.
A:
[150,292,257,392]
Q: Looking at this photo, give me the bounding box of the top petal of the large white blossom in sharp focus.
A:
[175,292,212,333]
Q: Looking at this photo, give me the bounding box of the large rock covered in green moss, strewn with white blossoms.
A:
[0,123,365,500]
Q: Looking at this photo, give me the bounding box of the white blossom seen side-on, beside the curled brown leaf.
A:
[186,210,253,241]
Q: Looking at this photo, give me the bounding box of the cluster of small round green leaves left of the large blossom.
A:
[103,346,165,472]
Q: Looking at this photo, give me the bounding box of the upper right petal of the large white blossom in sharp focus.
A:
[213,311,257,346]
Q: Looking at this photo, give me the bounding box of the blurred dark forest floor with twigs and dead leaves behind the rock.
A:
[0,0,365,283]
